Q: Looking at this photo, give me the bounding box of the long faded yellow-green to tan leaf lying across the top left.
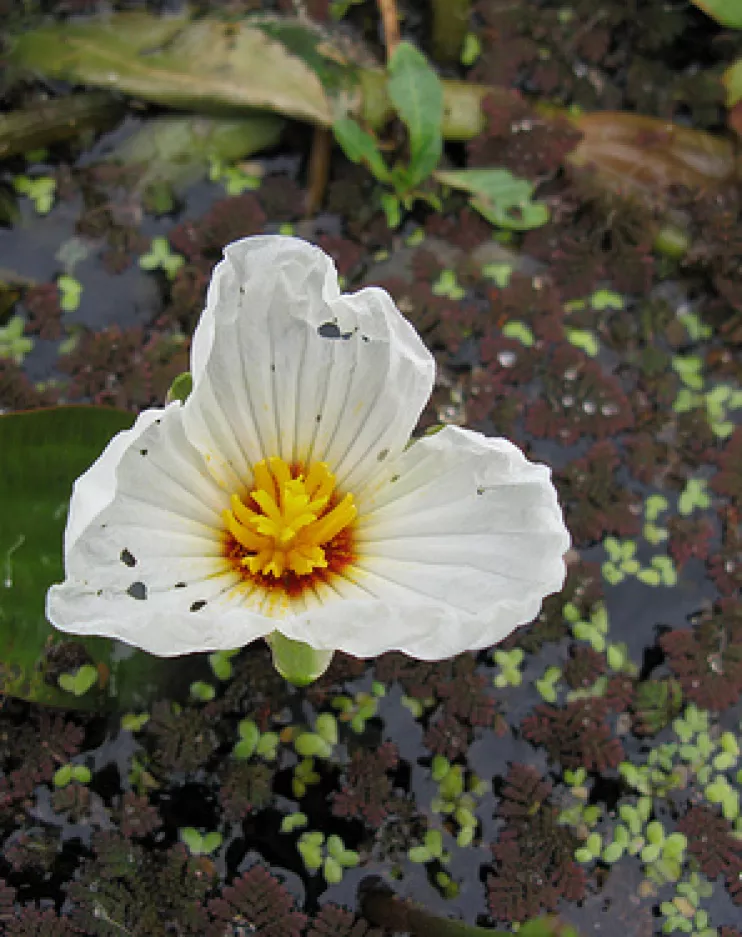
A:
[6,12,343,126]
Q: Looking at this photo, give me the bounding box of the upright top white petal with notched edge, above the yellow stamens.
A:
[184,236,434,490]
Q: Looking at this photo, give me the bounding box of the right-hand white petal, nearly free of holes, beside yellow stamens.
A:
[278,427,569,659]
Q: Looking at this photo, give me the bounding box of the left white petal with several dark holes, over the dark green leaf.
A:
[47,403,272,656]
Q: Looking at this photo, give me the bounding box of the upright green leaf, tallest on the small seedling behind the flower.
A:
[387,42,443,189]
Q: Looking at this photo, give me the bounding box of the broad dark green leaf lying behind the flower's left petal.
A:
[0,407,208,709]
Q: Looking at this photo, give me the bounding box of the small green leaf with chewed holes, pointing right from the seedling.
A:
[435,169,549,231]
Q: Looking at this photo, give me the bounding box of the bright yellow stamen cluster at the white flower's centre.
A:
[223,458,358,579]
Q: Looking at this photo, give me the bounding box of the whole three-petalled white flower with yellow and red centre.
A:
[47,237,569,660]
